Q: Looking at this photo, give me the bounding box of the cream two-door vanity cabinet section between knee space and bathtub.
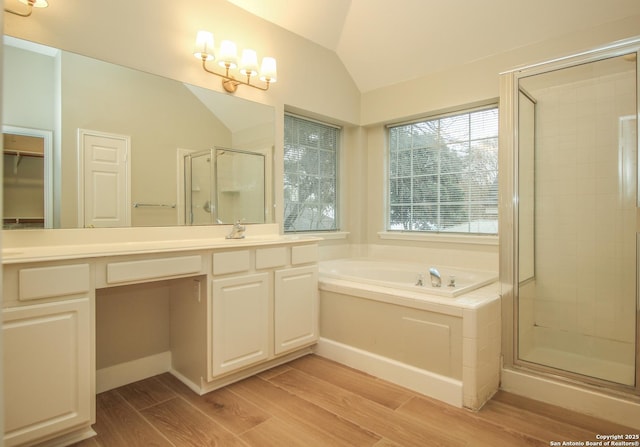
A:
[171,243,318,393]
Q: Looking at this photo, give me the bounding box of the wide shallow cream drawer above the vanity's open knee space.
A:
[107,255,202,284]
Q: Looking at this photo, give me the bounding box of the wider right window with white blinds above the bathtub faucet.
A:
[388,106,498,234]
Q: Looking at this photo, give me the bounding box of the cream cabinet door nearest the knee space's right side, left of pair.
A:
[211,273,269,376]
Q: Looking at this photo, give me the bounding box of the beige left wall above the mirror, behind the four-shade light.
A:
[5,0,360,233]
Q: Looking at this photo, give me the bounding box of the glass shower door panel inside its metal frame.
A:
[516,49,639,387]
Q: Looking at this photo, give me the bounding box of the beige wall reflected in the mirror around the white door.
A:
[61,53,231,228]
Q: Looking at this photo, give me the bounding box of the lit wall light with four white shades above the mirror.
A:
[193,31,277,93]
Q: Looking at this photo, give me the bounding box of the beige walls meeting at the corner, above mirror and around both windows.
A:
[5,0,640,256]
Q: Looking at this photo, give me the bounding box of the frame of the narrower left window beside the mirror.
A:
[282,111,344,235]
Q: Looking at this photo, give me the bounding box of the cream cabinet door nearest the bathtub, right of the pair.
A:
[274,265,318,354]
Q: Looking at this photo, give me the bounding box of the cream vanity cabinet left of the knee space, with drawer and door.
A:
[2,263,94,447]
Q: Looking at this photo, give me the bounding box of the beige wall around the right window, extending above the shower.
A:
[358,15,640,264]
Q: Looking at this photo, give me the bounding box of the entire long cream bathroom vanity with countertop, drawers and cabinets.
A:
[2,225,318,447]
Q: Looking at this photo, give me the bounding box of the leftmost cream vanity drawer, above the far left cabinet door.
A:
[18,264,91,301]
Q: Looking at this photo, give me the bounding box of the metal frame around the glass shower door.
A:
[498,38,640,400]
